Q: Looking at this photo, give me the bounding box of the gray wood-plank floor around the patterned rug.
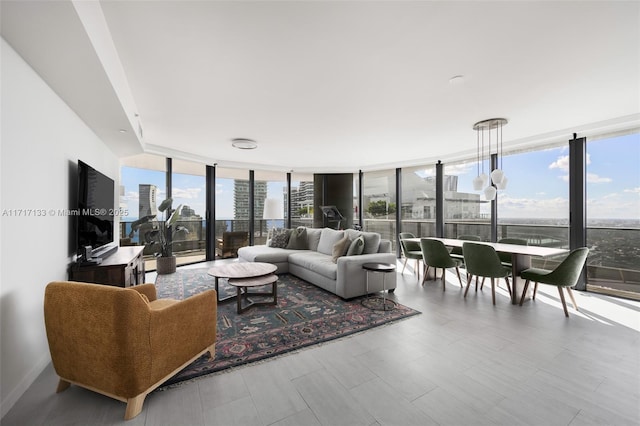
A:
[1,265,640,426]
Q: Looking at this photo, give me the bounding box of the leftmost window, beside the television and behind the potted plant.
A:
[120,154,167,271]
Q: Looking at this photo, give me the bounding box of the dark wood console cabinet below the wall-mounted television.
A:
[69,246,145,287]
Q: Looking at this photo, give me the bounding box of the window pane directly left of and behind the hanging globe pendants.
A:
[443,161,491,241]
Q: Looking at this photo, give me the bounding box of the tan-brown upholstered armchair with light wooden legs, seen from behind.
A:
[44,281,217,420]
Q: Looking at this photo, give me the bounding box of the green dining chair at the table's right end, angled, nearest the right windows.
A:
[520,247,589,317]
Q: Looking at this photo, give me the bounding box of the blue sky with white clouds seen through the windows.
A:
[121,133,640,225]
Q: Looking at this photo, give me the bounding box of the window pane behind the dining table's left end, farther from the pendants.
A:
[400,165,438,237]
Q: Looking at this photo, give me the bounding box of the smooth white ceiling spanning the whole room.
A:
[1,0,640,172]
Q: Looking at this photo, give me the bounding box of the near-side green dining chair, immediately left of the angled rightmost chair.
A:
[462,242,511,305]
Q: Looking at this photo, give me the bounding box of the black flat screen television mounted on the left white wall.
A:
[76,160,117,262]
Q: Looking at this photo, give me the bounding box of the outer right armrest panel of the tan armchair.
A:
[150,290,218,382]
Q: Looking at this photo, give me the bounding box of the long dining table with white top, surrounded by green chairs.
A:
[408,237,569,305]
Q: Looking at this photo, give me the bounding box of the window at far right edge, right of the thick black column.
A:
[586,133,640,298]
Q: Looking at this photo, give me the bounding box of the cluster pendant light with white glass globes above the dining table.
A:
[473,118,508,200]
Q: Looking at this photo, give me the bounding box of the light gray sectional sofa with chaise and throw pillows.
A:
[238,227,397,299]
